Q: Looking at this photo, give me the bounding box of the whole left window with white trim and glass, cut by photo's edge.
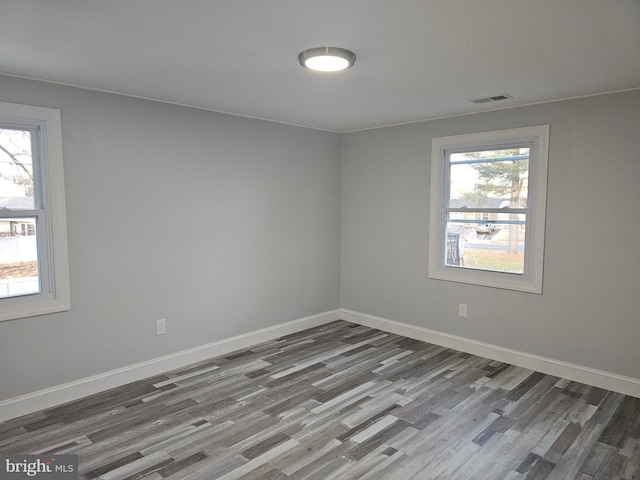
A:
[0,102,70,321]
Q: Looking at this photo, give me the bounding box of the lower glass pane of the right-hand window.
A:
[445,220,525,274]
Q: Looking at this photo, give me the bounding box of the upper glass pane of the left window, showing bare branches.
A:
[0,128,34,210]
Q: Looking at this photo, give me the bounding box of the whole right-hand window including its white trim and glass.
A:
[429,125,549,293]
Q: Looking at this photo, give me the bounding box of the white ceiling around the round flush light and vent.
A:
[0,0,640,132]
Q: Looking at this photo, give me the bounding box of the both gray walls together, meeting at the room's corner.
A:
[0,77,640,400]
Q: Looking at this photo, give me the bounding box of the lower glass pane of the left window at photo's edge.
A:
[0,217,40,298]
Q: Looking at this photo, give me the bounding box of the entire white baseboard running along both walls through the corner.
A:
[0,309,640,422]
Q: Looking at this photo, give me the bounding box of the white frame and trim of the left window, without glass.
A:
[0,102,71,321]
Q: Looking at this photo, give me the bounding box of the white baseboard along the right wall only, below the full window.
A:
[340,309,640,398]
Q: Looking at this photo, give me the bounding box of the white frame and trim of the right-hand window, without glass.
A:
[428,125,549,294]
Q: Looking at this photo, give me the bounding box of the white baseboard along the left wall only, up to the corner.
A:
[0,310,340,422]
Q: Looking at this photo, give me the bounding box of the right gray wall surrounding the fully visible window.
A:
[341,91,640,378]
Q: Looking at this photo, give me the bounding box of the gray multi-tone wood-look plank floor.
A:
[0,321,640,480]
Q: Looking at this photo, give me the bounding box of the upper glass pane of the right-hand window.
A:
[449,147,530,208]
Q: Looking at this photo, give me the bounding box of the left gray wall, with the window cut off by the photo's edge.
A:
[0,77,340,400]
